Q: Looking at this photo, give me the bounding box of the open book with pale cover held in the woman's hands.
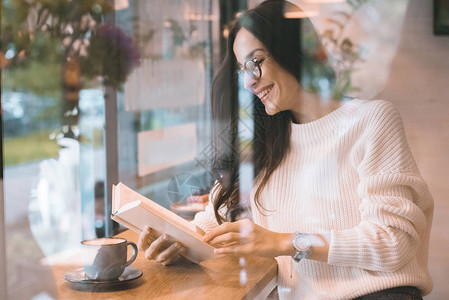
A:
[111,182,218,263]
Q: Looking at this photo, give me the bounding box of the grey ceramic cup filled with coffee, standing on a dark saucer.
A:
[81,238,137,280]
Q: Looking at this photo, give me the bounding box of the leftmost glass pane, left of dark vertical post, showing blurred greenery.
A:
[0,1,115,299]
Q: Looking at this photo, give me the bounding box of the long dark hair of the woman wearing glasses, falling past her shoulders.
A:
[212,0,302,223]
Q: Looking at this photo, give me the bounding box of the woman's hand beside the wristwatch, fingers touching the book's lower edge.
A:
[203,220,295,257]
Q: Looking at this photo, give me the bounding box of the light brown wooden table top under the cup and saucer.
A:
[53,231,277,300]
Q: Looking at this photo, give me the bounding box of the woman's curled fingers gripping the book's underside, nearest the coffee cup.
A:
[137,227,185,266]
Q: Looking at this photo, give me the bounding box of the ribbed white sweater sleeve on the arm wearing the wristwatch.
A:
[328,102,433,272]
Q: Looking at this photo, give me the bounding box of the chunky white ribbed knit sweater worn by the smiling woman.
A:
[194,100,433,300]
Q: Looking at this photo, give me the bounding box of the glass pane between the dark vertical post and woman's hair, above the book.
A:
[116,0,214,218]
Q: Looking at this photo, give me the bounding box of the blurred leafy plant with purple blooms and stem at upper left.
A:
[0,0,139,138]
